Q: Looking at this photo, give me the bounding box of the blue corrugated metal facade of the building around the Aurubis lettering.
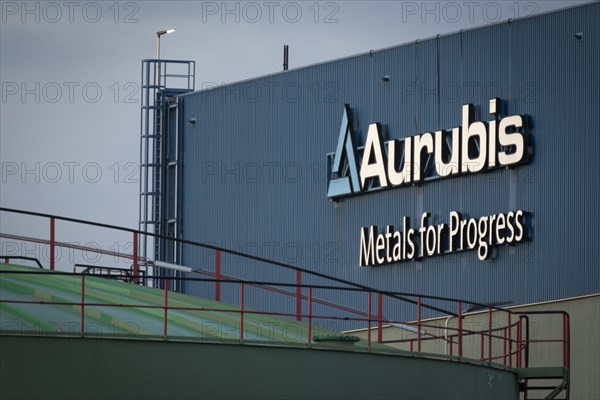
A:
[178,3,600,322]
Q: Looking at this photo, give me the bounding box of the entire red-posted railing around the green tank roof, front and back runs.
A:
[0,208,570,368]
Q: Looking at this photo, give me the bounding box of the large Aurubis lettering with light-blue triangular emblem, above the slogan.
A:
[327,99,529,199]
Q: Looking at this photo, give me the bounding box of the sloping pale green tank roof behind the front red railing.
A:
[0,264,378,348]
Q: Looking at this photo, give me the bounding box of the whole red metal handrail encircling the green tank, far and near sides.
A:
[0,208,570,376]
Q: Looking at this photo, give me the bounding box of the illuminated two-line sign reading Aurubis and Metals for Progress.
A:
[327,99,530,266]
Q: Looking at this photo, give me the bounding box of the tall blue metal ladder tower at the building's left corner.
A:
[138,59,196,284]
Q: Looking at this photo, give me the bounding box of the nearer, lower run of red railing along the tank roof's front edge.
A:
[0,270,570,374]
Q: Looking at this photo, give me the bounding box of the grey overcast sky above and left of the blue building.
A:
[0,1,587,268]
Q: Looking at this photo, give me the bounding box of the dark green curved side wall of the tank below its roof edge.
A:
[0,336,518,399]
